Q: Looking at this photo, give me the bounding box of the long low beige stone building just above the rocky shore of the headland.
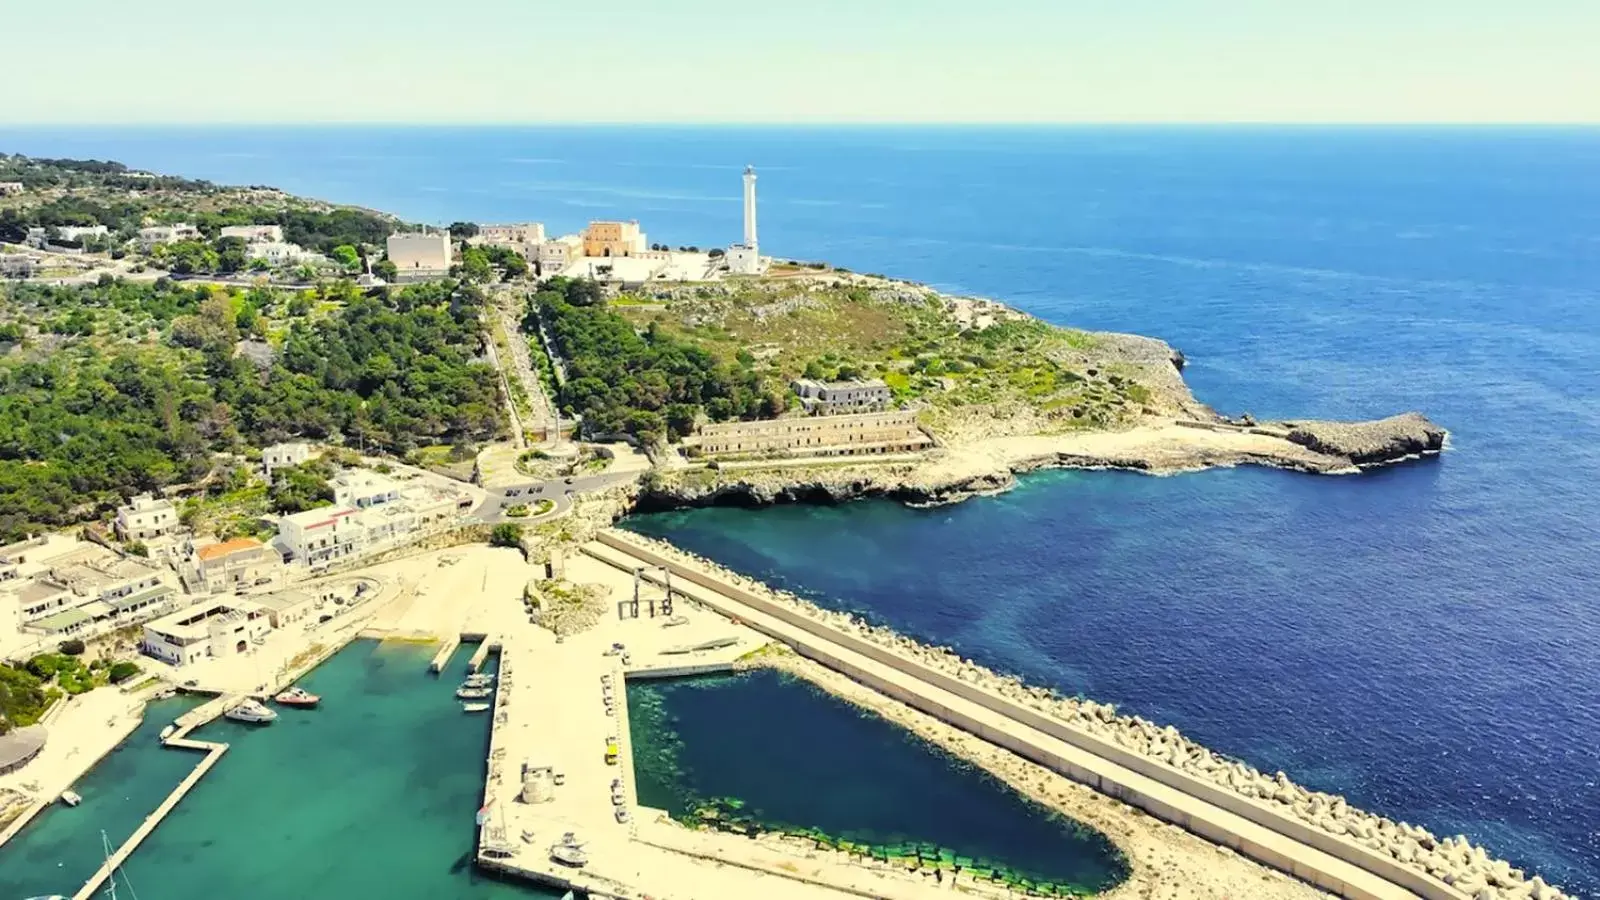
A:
[690,410,933,456]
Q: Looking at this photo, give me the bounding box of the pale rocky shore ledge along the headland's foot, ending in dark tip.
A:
[635,413,1448,512]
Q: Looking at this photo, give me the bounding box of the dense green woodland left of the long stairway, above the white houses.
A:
[0,280,504,540]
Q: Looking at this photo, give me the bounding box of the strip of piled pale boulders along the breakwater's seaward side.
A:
[608,533,1568,900]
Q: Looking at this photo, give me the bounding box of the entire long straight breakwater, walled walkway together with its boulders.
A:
[598,530,1562,900]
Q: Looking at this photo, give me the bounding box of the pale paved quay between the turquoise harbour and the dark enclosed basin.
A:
[467,556,1011,900]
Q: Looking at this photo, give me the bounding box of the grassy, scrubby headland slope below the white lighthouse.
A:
[605,277,1192,439]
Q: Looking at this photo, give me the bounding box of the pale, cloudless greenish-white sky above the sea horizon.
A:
[12,0,1600,125]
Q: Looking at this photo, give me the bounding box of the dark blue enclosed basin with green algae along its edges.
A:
[627,671,1128,895]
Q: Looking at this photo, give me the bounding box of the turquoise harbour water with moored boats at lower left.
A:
[0,641,554,900]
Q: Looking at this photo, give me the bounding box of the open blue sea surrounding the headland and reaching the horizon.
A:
[0,127,1600,897]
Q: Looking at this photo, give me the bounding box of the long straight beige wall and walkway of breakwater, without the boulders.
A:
[590,530,1466,900]
